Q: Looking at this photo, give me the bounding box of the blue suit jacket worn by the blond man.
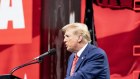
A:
[65,44,110,79]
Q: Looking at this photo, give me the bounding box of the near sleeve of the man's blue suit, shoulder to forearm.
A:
[65,49,108,79]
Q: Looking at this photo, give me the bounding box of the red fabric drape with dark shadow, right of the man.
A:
[94,5,140,79]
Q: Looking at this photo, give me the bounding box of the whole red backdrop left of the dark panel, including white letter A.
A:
[0,0,40,79]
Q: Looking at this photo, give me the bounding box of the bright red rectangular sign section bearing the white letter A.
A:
[0,0,32,44]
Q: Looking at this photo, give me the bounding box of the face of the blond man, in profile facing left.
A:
[64,29,78,52]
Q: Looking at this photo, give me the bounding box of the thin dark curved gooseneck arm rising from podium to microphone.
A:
[9,58,42,75]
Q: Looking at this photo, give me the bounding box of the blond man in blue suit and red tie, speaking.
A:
[62,23,110,79]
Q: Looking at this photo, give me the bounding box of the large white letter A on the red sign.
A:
[0,0,25,29]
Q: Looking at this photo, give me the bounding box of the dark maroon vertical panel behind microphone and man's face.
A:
[41,0,81,79]
